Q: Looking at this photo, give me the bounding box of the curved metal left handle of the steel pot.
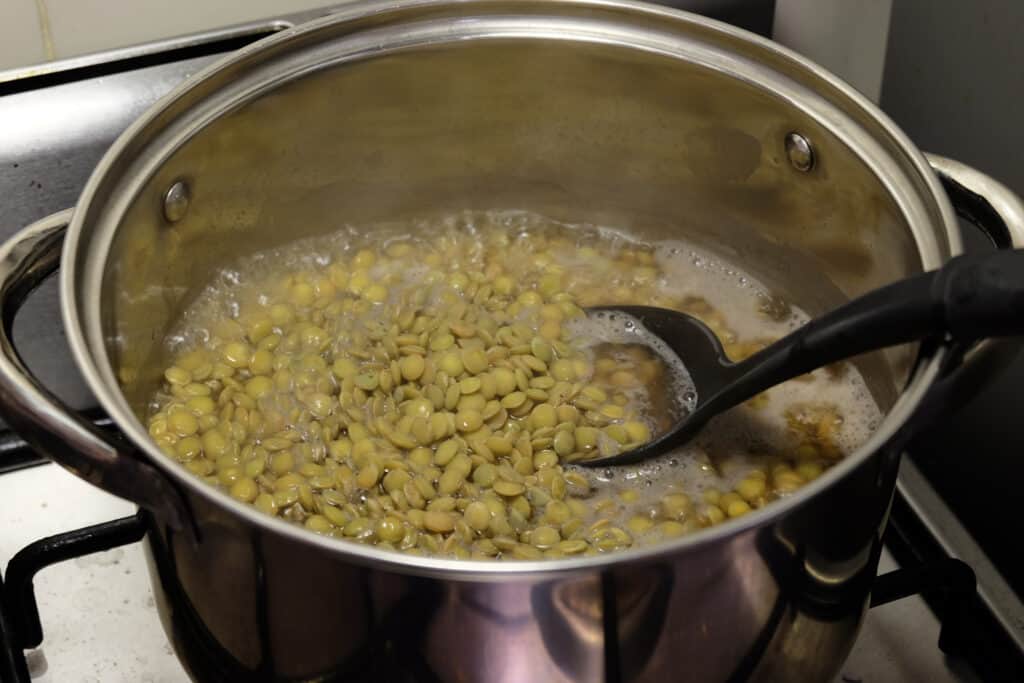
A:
[0,209,194,536]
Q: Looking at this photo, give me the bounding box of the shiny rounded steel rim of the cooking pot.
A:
[60,0,963,581]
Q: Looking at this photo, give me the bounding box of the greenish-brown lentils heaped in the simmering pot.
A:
[148,215,839,559]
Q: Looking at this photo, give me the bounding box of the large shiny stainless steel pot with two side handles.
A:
[0,0,1024,682]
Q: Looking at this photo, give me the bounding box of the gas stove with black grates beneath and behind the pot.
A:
[0,5,1024,683]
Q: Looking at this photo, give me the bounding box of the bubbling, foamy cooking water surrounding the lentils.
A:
[152,212,882,557]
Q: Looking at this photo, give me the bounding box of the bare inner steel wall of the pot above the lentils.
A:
[101,37,922,414]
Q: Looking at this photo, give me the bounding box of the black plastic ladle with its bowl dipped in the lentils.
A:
[574,250,1024,467]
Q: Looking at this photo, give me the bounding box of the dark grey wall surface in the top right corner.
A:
[882,0,1024,195]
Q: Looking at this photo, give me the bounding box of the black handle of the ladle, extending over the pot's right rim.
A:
[716,250,1024,412]
